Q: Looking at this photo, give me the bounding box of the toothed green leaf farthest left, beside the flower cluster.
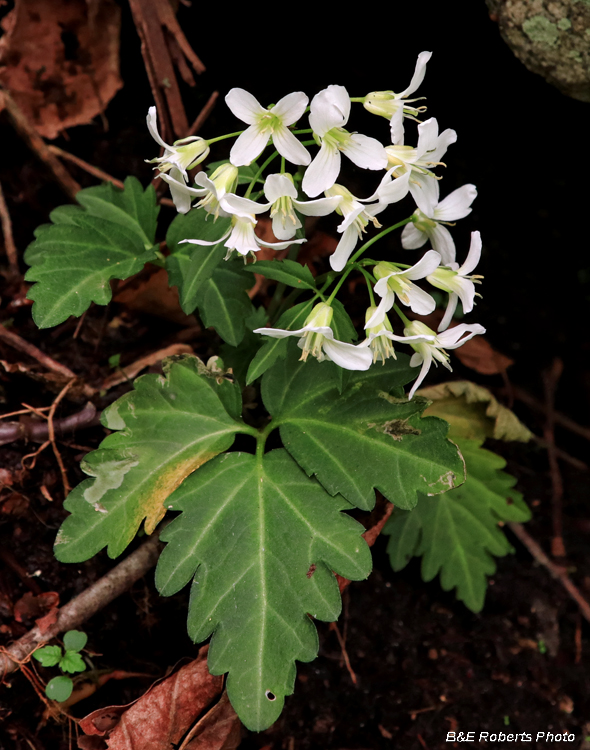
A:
[25,178,158,328]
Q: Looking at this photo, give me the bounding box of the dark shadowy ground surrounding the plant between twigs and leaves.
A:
[0,0,590,750]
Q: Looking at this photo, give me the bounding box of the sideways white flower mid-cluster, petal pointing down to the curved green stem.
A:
[326,167,410,271]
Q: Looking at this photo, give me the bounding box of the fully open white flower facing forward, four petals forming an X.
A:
[225,89,311,167]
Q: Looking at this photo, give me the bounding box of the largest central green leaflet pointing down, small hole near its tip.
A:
[156,449,371,731]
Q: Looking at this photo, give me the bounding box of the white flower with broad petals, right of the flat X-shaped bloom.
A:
[302,86,387,198]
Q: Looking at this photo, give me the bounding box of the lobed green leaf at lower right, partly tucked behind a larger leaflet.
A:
[384,440,530,612]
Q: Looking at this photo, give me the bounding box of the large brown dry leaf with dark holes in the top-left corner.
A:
[0,0,123,138]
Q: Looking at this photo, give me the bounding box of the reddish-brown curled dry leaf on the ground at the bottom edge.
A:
[79,648,237,750]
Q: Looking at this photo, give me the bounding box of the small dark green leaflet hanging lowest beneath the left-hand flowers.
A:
[197,259,255,346]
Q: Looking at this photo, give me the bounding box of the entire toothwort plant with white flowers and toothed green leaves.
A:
[26,52,527,730]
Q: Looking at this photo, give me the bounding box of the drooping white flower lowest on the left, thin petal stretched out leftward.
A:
[254,302,372,370]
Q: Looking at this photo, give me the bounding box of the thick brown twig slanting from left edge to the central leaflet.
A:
[0,534,160,681]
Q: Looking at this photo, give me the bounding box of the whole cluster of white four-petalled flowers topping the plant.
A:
[147,52,485,397]
